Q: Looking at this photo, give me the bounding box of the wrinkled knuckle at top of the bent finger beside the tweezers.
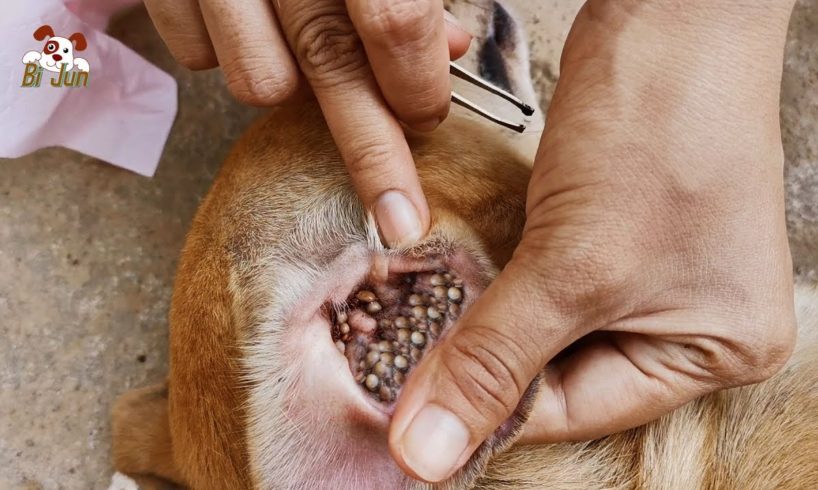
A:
[360,0,434,46]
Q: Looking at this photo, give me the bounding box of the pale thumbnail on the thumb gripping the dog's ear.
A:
[401,405,469,482]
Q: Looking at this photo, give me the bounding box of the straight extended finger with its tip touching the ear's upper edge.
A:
[277,0,429,247]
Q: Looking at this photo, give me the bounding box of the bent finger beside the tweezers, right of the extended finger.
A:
[347,0,451,130]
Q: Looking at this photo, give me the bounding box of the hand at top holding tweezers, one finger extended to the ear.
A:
[145,0,471,246]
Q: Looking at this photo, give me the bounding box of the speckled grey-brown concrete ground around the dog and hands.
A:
[0,0,818,490]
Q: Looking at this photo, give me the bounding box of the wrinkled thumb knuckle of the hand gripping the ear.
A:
[443,326,526,422]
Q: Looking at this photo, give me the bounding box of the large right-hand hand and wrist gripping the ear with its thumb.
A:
[389,0,795,482]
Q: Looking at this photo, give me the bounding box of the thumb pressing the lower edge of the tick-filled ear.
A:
[389,258,578,482]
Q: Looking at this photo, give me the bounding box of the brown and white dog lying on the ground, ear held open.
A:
[113,3,818,490]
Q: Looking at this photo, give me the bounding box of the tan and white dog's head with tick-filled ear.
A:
[171,4,538,489]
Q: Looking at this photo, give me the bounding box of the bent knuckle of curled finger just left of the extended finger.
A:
[223,60,297,105]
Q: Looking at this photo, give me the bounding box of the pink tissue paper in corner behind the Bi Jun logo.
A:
[0,0,177,176]
